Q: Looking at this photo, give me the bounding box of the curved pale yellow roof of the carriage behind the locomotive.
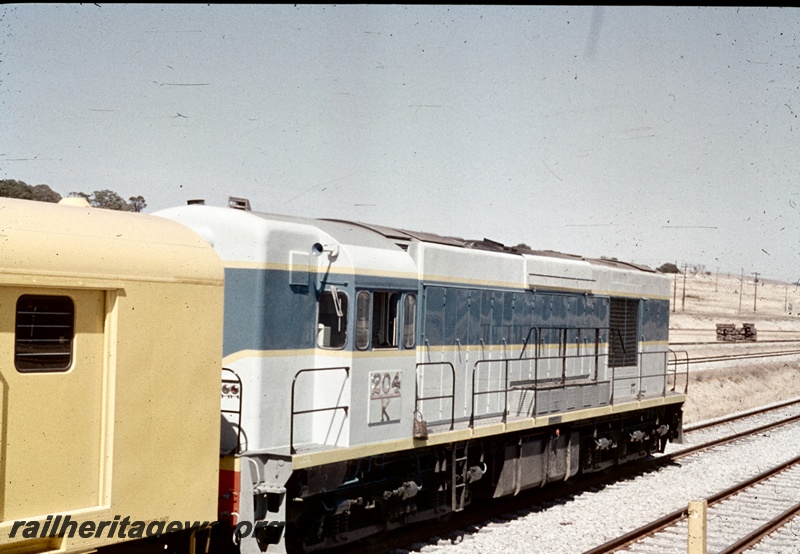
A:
[0,198,224,286]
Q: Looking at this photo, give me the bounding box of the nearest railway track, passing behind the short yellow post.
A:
[584,456,800,554]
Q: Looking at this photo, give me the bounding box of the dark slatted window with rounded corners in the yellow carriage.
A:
[14,295,75,373]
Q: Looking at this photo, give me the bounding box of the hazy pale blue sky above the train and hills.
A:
[0,4,800,282]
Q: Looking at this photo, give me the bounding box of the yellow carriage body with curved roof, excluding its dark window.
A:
[0,199,223,552]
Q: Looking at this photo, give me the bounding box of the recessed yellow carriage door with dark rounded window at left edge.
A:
[0,286,105,521]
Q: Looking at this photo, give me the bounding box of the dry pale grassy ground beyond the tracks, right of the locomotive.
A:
[670,273,800,423]
